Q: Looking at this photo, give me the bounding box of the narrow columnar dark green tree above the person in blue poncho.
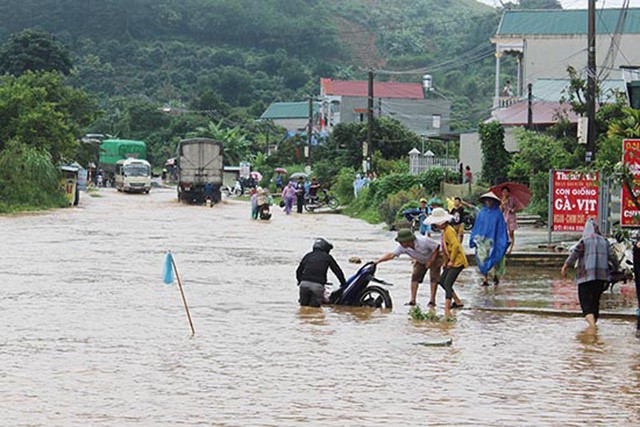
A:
[478,122,509,185]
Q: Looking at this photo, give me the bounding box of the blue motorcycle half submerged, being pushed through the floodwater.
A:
[325,262,393,310]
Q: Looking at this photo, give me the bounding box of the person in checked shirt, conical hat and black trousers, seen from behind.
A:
[560,218,616,333]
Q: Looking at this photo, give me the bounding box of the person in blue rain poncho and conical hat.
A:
[469,192,509,286]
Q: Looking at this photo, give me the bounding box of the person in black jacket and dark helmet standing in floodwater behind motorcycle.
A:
[296,238,346,307]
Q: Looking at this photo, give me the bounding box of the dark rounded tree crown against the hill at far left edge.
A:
[0,29,73,76]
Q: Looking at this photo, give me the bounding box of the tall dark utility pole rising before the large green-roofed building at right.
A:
[585,0,596,164]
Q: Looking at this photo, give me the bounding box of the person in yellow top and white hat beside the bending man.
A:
[425,208,469,318]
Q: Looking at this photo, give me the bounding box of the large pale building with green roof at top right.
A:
[491,9,640,108]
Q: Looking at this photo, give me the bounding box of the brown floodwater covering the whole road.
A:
[0,189,640,427]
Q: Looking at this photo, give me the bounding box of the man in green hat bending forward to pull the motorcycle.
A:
[375,229,450,307]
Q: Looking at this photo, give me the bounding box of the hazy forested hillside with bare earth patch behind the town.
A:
[0,0,499,129]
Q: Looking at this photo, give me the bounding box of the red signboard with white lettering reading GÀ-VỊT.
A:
[551,170,600,231]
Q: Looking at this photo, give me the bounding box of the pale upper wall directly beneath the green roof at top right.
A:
[524,34,640,88]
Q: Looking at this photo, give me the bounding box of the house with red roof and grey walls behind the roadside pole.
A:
[320,78,451,136]
